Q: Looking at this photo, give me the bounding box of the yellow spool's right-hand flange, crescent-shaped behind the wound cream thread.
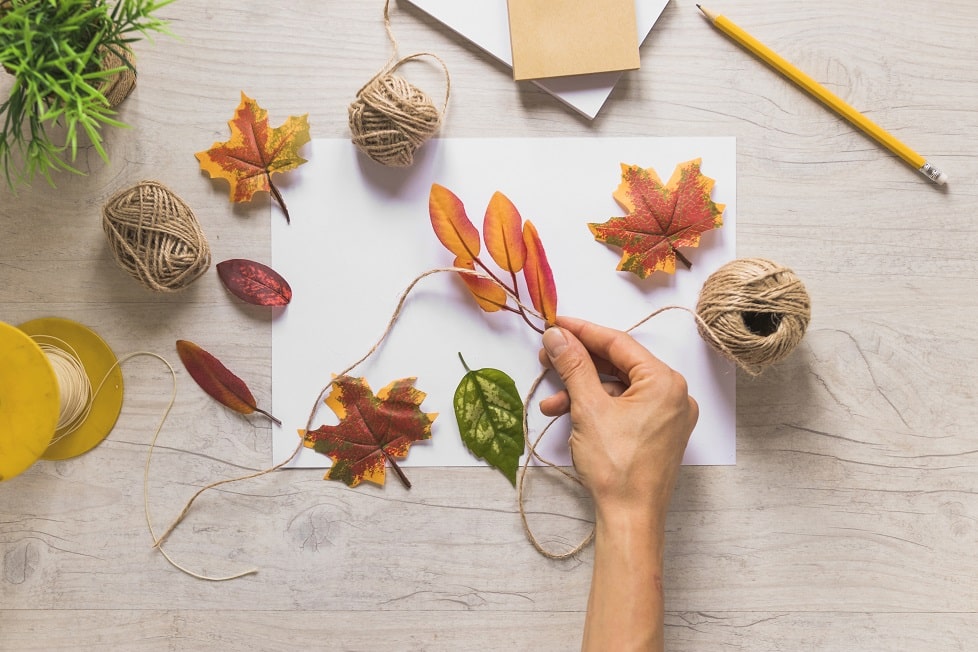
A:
[19,317,123,460]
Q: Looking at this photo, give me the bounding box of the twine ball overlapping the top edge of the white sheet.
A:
[349,74,441,167]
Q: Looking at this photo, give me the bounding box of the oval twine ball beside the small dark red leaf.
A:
[102,181,211,292]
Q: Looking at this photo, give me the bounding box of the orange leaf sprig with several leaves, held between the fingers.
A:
[428,183,557,333]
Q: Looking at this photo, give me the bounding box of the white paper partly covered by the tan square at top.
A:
[398,0,669,120]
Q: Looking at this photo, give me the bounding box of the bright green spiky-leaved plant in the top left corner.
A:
[0,0,173,188]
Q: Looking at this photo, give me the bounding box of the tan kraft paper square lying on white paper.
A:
[508,0,639,81]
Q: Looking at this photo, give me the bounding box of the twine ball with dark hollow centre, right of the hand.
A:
[696,258,811,376]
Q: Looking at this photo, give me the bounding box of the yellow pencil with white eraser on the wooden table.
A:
[696,5,947,186]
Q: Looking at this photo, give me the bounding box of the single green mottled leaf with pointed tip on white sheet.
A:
[453,354,524,486]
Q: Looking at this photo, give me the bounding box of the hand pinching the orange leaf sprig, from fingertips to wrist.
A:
[540,317,699,528]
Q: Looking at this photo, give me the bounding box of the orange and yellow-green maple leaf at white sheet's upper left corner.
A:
[196,93,309,221]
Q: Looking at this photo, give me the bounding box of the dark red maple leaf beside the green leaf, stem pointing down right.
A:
[300,376,438,488]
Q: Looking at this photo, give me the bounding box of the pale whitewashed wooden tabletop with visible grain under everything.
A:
[0,0,978,651]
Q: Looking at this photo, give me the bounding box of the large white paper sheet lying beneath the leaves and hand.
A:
[272,138,736,467]
